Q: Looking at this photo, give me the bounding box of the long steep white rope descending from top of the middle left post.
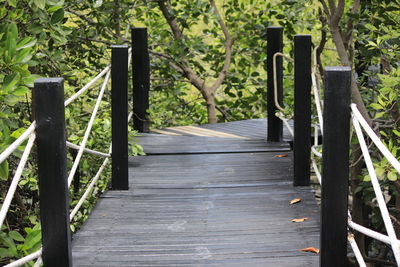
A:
[68,70,111,187]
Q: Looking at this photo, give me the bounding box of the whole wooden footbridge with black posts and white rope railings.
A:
[7,27,390,267]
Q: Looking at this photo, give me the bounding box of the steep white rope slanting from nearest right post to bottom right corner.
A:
[352,111,400,265]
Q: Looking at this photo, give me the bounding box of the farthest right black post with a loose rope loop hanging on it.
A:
[267,26,283,142]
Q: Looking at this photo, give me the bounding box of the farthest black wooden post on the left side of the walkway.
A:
[132,28,150,133]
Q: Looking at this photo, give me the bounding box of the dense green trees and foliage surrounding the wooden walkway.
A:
[0,0,400,264]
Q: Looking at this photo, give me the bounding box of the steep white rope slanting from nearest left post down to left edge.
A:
[0,133,36,228]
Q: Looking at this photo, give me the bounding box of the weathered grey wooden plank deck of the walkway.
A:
[73,120,319,267]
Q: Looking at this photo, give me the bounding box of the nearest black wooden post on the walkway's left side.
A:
[33,78,72,266]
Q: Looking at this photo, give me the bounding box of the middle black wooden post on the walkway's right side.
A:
[293,35,311,186]
